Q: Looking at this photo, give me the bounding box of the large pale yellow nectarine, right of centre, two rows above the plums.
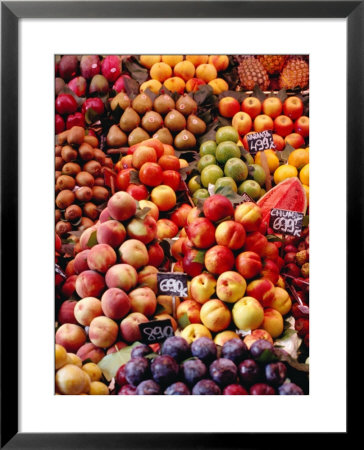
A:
[232,296,264,331]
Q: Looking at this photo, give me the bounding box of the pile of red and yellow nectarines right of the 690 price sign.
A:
[172,194,292,343]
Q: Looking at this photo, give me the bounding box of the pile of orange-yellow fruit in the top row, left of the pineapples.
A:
[139,55,229,94]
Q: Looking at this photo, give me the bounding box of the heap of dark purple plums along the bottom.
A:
[115,336,304,395]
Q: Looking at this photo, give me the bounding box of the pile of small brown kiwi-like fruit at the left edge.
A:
[55,126,113,236]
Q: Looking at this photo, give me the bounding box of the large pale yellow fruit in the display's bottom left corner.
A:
[56,364,91,395]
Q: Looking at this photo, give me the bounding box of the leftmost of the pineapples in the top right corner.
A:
[238,56,269,91]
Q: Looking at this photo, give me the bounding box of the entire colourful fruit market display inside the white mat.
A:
[55,55,309,395]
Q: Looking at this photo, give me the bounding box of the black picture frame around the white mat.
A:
[0,1,358,450]
